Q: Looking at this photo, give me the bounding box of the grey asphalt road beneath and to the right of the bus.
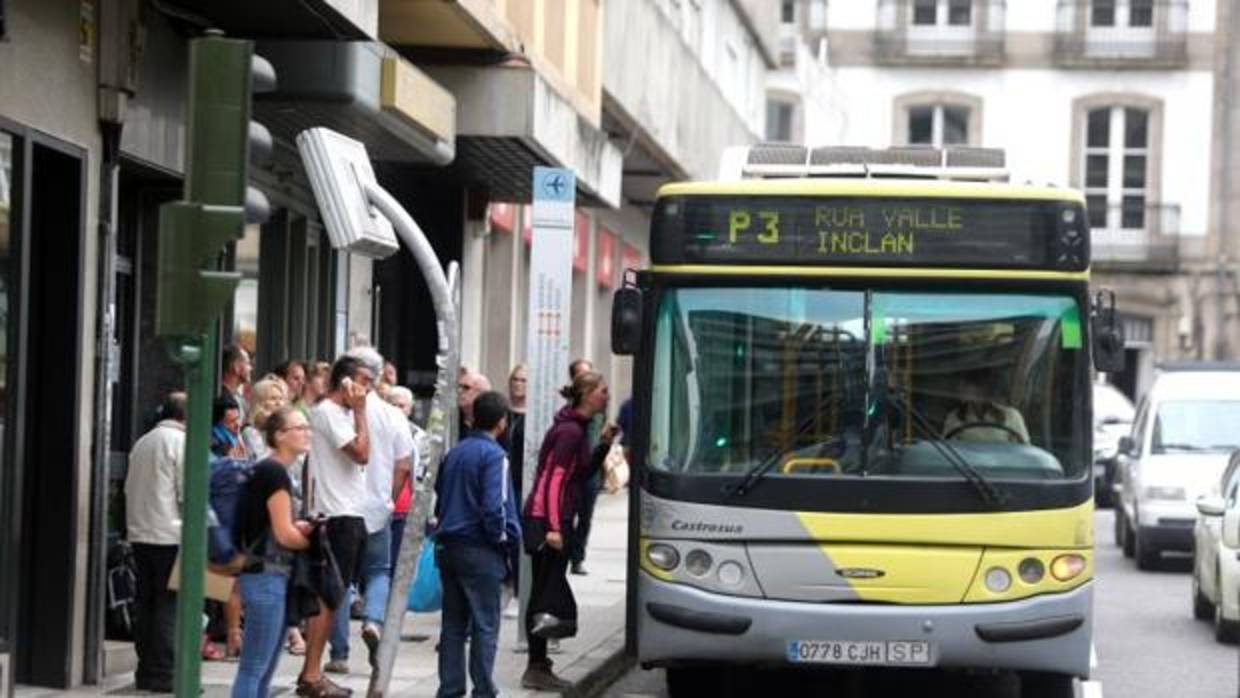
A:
[605,511,1240,698]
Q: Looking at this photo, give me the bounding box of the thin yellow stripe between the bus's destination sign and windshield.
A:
[650,264,1089,281]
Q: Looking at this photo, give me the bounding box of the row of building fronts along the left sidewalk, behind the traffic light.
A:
[0,0,779,696]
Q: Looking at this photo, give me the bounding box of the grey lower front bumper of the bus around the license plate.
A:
[637,572,1094,678]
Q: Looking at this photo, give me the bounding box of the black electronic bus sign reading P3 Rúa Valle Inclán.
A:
[651,196,1087,269]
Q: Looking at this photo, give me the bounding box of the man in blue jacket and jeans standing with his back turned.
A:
[435,391,521,698]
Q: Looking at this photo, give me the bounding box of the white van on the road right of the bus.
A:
[1115,367,1240,569]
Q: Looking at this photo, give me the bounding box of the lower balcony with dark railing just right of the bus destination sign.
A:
[1090,203,1179,273]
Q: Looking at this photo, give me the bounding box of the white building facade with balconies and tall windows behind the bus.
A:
[802,0,1225,394]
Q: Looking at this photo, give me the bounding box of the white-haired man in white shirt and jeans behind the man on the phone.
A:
[327,346,418,672]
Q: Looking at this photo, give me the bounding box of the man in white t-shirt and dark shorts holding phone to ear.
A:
[298,356,374,696]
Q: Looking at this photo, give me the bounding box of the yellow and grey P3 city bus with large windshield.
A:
[613,145,1122,697]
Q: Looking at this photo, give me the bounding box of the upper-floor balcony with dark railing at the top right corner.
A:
[1055,0,1188,68]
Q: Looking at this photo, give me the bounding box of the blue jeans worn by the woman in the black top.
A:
[232,574,289,698]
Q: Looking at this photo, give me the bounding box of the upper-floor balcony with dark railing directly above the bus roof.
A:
[874,0,1007,66]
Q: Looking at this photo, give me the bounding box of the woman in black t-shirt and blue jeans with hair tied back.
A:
[232,407,312,698]
